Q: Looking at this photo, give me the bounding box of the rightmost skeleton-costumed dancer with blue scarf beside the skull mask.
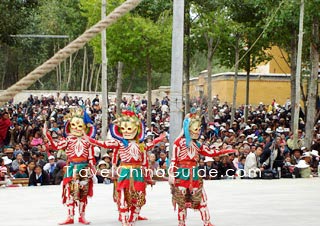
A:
[169,114,234,226]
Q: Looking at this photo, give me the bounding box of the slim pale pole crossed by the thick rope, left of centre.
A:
[101,0,108,156]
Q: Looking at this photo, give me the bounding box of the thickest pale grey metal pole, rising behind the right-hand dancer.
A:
[170,0,184,157]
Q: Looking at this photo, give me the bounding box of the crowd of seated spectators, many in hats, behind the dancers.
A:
[0,94,320,186]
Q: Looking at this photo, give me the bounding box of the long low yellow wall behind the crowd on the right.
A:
[190,71,290,106]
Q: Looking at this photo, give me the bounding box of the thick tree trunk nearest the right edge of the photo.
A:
[304,17,319,150]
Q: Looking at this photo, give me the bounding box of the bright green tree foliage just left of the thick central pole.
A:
[81,0,171,91]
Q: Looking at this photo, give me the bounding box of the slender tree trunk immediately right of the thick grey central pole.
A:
[184,0,191,114]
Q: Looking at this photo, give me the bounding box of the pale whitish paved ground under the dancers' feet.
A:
[0,178,320,226]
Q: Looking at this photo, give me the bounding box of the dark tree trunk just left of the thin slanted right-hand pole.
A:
[290,29,298,131]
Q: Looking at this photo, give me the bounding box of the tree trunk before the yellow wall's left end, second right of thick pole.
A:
[207,37,213,122]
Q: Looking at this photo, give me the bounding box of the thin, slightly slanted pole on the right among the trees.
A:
[293,0,304,149]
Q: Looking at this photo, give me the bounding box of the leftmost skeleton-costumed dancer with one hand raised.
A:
[43,108,95,225]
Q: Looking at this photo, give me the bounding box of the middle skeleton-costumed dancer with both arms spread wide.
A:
[85,111,164,226]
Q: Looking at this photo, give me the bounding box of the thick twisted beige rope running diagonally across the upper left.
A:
[0,0,142,106]
